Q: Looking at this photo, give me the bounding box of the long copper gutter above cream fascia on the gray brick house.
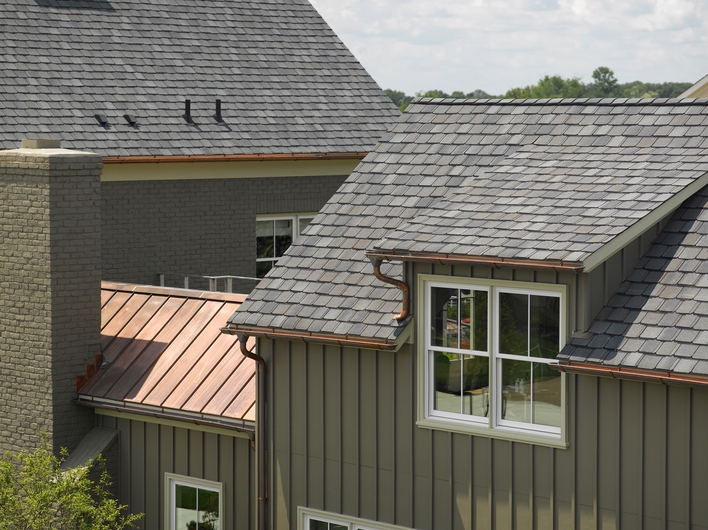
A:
[102,152,368,164]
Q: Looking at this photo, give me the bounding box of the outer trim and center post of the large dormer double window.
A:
[416,274,569,448]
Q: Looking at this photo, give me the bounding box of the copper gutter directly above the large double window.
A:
[366,252,584,273]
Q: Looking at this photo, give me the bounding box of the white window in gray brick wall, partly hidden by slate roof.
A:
[256,213,316,278]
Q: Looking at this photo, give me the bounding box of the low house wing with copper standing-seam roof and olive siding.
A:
[78,281,256,529]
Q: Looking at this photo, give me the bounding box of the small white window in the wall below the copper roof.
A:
[165,473,224,530]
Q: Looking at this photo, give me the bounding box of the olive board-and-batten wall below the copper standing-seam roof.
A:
[96,414,256,530]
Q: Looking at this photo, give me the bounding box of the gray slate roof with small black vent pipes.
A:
[0,0,399,156]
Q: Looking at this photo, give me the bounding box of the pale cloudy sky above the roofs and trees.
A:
[310,0,708,95]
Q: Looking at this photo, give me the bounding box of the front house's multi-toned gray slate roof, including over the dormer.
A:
[231,100,708,350]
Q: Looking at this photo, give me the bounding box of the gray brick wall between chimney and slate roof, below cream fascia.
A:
[101,176,346,290]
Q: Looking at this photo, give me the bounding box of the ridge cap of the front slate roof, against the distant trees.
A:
[411,97,708,107]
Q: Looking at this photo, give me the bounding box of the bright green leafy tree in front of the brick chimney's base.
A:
[0,436,142,530]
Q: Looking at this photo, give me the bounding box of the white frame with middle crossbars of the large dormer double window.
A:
[416,274,568,448]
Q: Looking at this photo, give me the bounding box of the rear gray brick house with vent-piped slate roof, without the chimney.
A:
[0,0,399,292]
